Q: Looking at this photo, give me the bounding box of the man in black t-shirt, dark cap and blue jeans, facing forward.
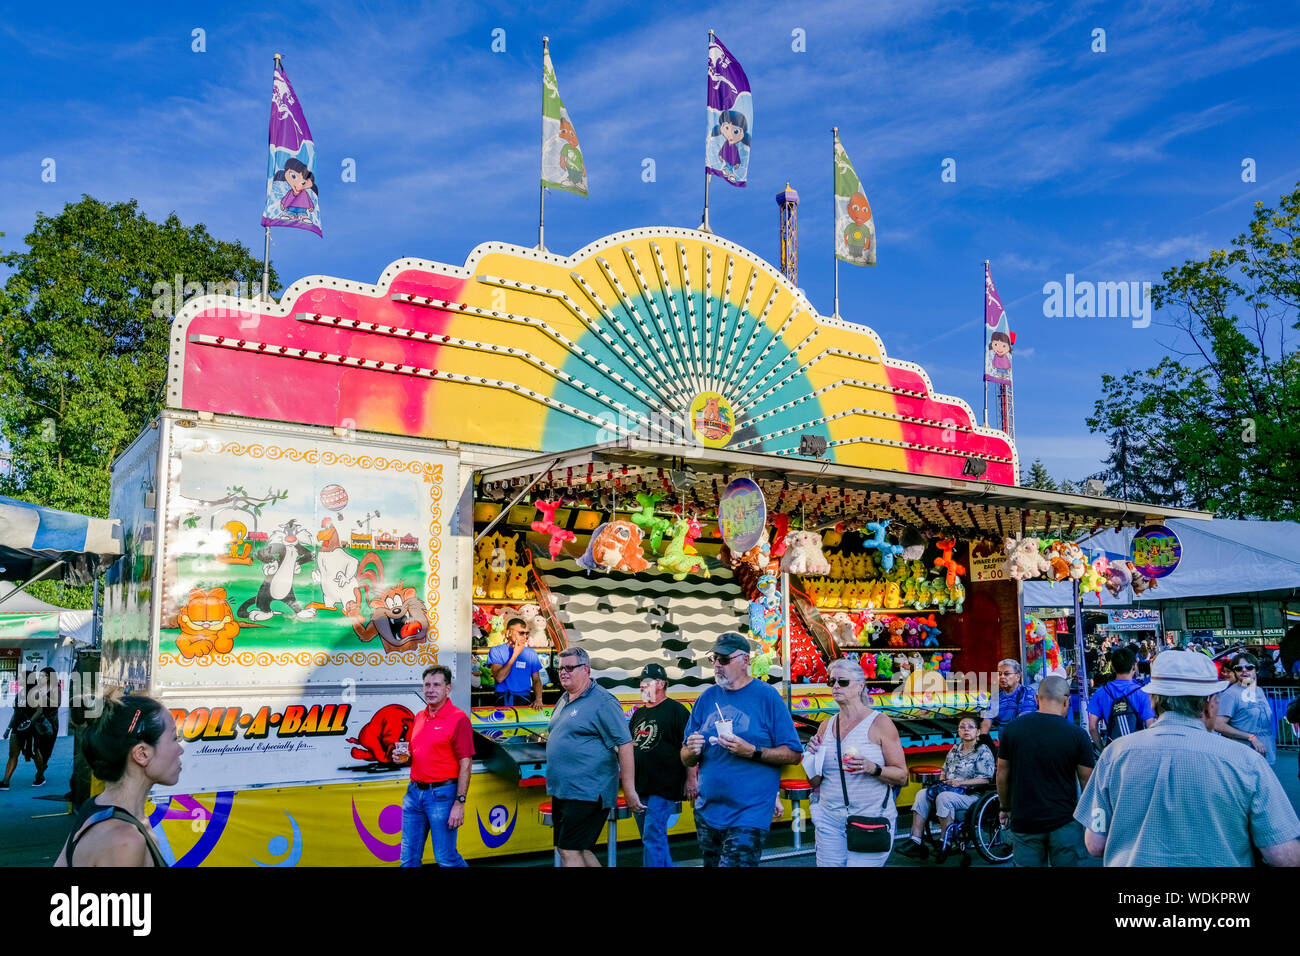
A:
[628,663,699,866]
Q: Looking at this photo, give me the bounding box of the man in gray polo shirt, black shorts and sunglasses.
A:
[546,648,645,866]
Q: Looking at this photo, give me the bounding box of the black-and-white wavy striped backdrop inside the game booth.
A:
[534,558,749,692]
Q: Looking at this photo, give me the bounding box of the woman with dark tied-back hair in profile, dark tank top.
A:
[55,695,181,866]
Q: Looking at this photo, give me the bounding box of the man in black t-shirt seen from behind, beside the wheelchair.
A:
[997,676,1096,866]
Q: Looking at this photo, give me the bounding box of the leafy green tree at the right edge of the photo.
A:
[1088,187,1300,520]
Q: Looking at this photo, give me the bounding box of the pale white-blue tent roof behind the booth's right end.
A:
[1024,518,1300,607]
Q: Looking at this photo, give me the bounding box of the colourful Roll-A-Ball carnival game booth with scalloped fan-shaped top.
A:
[103,228,1206,866]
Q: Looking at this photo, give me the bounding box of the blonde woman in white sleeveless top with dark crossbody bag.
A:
[803,658,907,866]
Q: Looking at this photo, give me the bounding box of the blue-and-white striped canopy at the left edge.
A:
[0,496,122,584]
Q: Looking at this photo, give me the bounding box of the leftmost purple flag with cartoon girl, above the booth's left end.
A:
[261,59,321,235]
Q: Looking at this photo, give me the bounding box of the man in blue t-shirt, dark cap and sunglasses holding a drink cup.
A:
[681,632,803,866]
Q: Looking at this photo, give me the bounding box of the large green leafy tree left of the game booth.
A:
[0,196,277,601]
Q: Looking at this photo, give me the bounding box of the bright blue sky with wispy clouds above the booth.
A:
[0,0,1300,479]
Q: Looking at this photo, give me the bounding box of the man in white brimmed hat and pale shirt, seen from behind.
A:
[1074,650,1300,866]
